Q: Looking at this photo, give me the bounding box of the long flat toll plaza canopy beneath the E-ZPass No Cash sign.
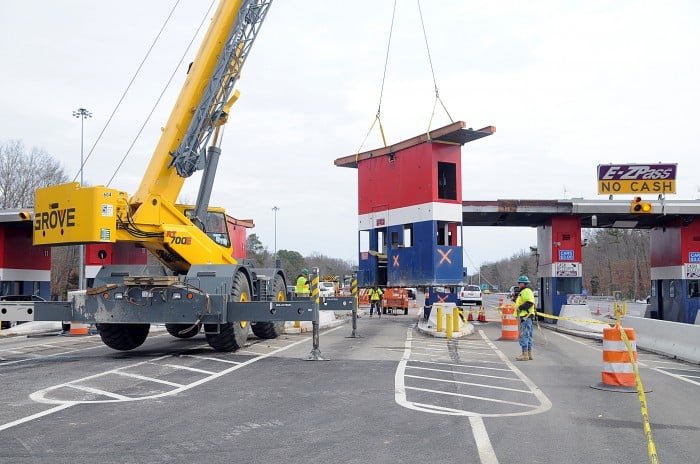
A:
[462,199,700,229]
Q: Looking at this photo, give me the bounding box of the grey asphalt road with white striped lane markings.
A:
[0,309,700,464]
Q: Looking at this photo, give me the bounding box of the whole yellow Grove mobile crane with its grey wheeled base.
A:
[28,0,310,351]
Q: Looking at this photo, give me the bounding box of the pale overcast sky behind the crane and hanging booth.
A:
[0,0,700,272]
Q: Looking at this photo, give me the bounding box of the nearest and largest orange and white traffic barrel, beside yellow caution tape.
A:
[602,326,637,388]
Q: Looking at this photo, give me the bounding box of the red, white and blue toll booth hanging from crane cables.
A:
[335,121,496,288]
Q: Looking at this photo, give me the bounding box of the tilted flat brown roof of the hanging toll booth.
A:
[334,121,496,168]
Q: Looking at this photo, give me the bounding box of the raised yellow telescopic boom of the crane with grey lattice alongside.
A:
[130,0,271,205]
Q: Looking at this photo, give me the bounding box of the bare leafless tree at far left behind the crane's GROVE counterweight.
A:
[0,140,68,208]
